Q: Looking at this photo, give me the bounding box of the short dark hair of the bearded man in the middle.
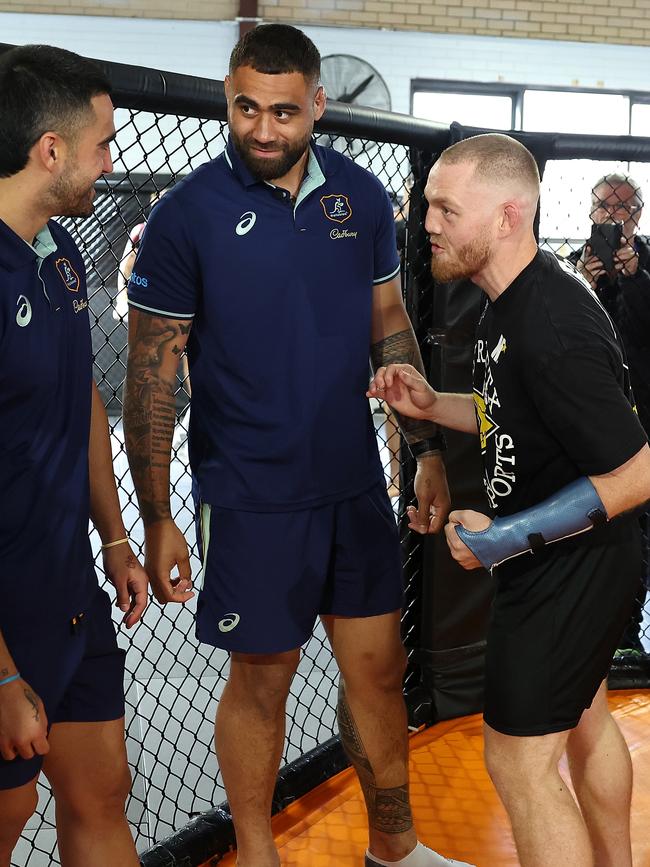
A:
[229,24,320,84]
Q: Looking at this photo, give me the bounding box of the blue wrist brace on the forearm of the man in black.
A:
[456,476,608,569]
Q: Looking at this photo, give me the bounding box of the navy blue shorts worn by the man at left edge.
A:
[0,588,125,789]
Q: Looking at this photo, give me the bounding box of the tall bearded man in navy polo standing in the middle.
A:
[124,25,466,867]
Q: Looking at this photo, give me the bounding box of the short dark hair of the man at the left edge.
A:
[0,45,111,178]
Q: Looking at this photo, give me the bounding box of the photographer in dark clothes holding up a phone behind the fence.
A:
[568,172,650,658]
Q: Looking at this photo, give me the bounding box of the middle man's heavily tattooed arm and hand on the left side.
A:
[124,307,194,602]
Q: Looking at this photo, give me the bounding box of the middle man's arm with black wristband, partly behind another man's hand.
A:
[370,278,451,534]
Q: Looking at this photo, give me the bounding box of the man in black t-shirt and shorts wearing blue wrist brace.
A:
[368,134,650,867]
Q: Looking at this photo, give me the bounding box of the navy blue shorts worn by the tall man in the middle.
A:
[196,483,402,653]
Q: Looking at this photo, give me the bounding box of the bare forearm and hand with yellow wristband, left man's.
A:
[88,382,149,629]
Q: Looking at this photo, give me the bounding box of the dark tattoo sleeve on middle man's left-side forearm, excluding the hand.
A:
[124,315,185,526]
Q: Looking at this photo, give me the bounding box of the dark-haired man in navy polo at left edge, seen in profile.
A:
[0,46,147,867]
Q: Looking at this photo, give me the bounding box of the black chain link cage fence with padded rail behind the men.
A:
[0,46,650,867]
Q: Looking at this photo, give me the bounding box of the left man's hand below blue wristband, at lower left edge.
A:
[0,678,50,762]
